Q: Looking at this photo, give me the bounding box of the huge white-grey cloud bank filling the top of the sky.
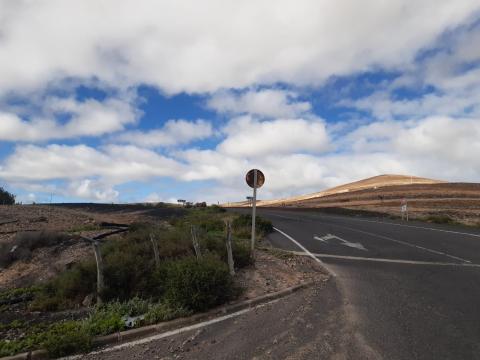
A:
[0,0,480,93]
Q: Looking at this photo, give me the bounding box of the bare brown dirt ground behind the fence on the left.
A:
[0,204,181,290]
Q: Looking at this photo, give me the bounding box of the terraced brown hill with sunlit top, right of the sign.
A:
[225,175,480,225]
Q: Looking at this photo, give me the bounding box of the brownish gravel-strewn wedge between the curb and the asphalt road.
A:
[77,268,366,360]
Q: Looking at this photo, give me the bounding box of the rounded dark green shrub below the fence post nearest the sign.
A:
[164,256,234,311]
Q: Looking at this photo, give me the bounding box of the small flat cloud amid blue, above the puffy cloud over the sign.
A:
[207,89,311,118]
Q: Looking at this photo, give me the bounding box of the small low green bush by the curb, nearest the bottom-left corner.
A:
[42,321,92,357]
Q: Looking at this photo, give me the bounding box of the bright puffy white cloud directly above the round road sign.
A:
[218,116,329,157]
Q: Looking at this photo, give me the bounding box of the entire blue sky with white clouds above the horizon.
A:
[0,0,480,203]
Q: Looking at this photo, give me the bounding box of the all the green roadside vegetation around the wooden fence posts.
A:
[0,207,271,356]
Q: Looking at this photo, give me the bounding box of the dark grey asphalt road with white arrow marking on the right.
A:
[251,208,480,360]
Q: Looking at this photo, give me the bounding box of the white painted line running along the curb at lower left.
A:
[64,299,280,360]
